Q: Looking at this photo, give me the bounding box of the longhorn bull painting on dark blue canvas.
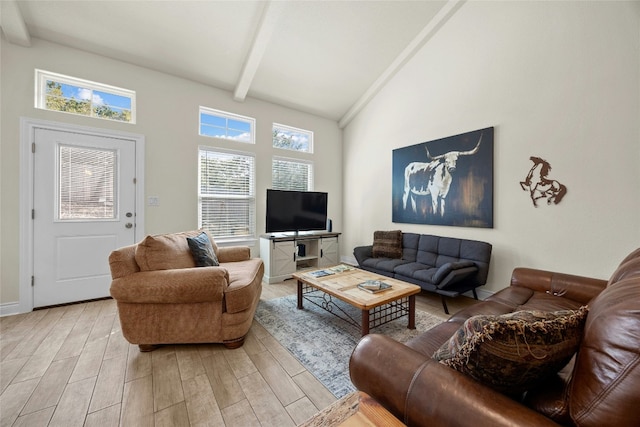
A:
[393,128,493,228]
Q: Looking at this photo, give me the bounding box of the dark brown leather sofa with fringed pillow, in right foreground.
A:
[350,249,640,427]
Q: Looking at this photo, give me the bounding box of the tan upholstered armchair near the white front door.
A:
[109,230,264,351]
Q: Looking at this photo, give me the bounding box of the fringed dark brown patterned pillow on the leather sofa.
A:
[433,306,588,394]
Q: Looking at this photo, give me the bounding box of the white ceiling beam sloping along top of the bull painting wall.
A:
[338,0,466,129]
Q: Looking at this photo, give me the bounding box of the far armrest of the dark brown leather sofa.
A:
[511,267,607,304]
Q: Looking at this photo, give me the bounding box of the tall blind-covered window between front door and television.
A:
[198,147,256,241]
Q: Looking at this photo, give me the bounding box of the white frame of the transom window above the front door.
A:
[34,68,136,124]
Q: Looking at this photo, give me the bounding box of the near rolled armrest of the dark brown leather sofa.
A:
[349,334,557,427]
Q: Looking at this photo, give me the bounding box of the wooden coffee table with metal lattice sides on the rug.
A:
[293,265,421,336]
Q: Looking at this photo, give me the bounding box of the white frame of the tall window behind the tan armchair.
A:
[198,145,257,246]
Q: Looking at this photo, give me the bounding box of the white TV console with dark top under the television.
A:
[260,231,340,283]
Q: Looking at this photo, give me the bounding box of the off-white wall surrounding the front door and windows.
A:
[0,38,342,304]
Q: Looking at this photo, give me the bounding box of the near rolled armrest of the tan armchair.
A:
[110,267,229,304]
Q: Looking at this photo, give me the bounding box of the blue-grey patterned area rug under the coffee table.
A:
[255,295,443,398]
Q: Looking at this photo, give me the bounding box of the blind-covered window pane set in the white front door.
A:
[57,145,118,221]
